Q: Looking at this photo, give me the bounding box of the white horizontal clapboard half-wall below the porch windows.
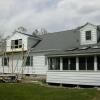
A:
[47,71,100,86]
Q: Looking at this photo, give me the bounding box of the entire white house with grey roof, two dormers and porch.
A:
[0,23,100,86]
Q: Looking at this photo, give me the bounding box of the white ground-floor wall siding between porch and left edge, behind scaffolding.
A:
[0,53,47,75]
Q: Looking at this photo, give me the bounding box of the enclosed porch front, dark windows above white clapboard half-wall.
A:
[47,55,100,86]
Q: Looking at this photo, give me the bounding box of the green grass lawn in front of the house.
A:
[0,84,100,100]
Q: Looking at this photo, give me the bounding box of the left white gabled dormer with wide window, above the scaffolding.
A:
[6,28,40,52]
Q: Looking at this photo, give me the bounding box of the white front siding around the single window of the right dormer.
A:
[80,24,97,45]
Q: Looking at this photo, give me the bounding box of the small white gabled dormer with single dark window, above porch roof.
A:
[80,23,99,45]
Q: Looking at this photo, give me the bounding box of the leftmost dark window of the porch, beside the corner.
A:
[49,58,60,70]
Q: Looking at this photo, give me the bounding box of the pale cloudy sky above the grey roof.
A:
[0,0,100,35]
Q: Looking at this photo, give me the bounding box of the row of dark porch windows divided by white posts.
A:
[48,55,100,71]
